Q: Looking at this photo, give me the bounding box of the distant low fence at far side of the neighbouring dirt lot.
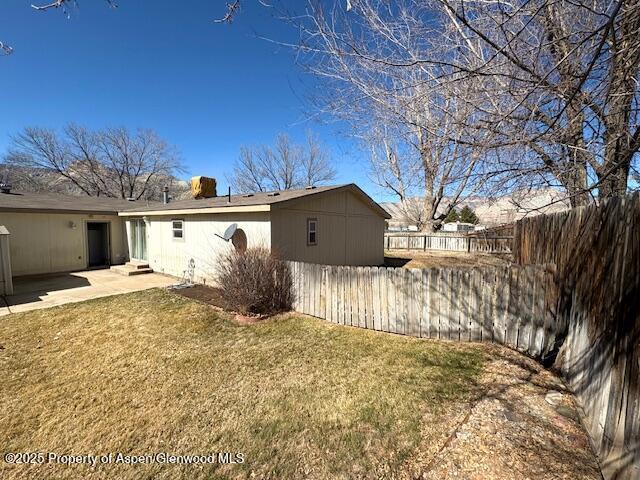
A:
[384,233,513,253]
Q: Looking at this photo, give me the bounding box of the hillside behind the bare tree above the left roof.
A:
[0,164,189,200]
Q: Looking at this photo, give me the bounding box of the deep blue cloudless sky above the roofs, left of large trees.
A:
[0,0,385,200]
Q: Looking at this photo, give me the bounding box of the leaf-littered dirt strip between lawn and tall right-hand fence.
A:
[413,347,601,480]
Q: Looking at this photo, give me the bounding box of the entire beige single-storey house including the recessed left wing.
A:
[0,184,389,281]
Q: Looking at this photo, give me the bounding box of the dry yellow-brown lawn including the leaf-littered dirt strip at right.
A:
[0,290,598,479]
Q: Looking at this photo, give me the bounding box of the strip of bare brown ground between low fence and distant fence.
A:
[384,250,511,268]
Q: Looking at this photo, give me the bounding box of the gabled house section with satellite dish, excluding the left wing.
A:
[119,184,389,281]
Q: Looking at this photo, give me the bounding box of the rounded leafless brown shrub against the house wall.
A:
[217,247,293,315]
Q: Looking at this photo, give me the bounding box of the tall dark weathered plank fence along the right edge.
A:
[513,193,640,480]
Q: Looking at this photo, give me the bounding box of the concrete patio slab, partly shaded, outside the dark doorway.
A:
[0,270,178,316]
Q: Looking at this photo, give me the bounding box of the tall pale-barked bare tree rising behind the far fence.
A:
[292,0,500,230]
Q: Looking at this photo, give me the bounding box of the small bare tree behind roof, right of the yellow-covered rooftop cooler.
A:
[230,133,336,193]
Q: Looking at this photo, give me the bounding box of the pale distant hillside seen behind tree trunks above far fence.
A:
[381,188,569,227]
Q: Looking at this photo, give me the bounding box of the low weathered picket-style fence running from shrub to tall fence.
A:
[289,262,562,358]
